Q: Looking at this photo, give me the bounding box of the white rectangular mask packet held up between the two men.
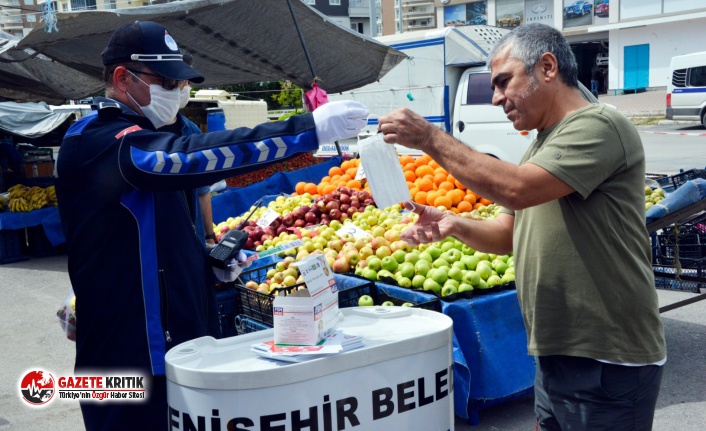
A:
[358,133,411,208]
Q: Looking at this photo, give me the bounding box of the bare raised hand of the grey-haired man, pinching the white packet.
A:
[378,108,443,153]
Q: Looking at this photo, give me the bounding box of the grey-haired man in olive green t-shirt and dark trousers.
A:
[379,24,666,431]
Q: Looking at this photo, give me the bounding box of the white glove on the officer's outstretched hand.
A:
[313,100,370,145]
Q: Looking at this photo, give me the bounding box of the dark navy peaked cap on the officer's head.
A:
[102,21,204,84]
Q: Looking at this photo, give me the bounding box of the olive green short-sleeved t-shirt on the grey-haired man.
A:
[504,104,666,364]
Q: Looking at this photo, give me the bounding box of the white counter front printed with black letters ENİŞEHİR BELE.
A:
[167,352,453,431]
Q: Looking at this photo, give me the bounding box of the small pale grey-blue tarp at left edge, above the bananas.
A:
[0,102,72,138]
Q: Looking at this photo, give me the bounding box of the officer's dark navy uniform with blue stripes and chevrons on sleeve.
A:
[56,98,318,430]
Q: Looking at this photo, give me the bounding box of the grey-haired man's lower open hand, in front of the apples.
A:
[400,202,457,246]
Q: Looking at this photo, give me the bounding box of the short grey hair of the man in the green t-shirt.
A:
[488,23,578,88]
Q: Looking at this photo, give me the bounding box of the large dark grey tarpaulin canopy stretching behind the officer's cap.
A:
[0,0,405,103]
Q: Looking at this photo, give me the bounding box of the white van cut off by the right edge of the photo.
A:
[666,51,706,126]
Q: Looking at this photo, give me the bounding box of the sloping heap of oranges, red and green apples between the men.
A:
[215,156,514,299]
